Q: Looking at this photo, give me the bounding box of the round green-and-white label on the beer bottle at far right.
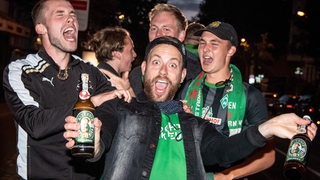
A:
[286,138,308,164]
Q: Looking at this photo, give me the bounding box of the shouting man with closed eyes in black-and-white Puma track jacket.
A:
[3,0,128,180]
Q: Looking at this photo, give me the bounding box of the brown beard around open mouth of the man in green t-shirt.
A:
[144,77,180,102]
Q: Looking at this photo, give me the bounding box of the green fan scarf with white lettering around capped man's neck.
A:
[185,64,246,136]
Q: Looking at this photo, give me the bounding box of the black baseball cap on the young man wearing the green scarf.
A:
[194,21,239,46]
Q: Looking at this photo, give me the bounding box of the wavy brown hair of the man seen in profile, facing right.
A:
[88,27,130,62]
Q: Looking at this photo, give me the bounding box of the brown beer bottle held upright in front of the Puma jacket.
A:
[71,73,94,158]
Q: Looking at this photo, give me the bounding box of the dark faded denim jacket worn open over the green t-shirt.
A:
[96,93,265,180]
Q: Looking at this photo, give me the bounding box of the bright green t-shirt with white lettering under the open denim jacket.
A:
[150,113,187,180]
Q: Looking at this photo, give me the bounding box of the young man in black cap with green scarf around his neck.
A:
[180,21,275,180]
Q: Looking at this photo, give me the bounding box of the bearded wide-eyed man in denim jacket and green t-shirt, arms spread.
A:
[64,37,317,180]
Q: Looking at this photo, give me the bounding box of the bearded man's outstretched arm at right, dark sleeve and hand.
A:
[202,113,317,166]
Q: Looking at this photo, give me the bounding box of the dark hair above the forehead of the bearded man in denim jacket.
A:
[144,36,187,67]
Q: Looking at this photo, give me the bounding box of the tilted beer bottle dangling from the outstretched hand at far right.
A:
[283,115,311,180]
